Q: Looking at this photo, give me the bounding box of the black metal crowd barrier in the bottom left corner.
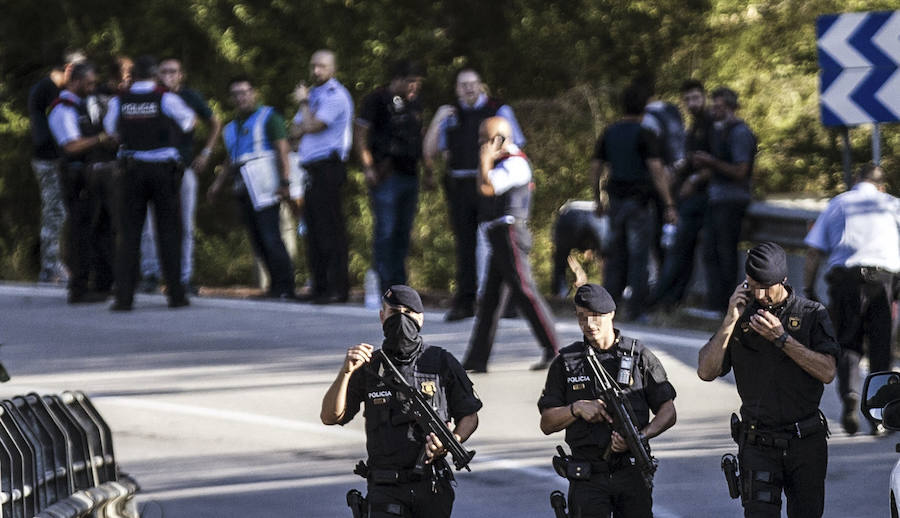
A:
[0,391,138,518]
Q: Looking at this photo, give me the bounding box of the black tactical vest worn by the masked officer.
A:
[365,345,450,470]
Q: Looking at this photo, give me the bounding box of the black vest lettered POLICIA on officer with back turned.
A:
[119,89,178,151]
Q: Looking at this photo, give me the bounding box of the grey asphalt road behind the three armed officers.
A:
[0,284,898,518]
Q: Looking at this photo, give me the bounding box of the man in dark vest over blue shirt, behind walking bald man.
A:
[425,68,525,322]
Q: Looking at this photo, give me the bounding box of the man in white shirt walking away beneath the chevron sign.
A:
[804,164,900,435]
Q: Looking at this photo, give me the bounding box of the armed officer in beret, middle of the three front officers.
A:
[538,284,676,518]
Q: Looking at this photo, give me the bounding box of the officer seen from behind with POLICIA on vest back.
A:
[103,56,196,311]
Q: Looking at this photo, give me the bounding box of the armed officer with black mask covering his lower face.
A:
[321,285,481,518]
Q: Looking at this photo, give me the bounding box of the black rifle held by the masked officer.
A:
[375,349,475,471]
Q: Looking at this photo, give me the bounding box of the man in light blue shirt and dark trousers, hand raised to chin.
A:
[290,50,353,304]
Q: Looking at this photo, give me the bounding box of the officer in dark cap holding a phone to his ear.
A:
[697,242,840,518]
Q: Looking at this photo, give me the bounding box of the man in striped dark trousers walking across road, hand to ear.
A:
[463,117,558,372]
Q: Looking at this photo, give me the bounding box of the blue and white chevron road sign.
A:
[816,11,900,126]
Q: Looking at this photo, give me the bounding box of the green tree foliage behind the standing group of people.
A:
[0,0,900,290]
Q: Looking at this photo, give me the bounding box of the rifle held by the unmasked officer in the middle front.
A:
[586,345,657,489]
